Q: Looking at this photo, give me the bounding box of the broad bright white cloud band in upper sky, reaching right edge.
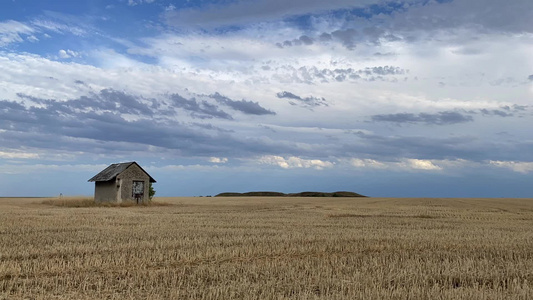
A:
[128,25,533,119]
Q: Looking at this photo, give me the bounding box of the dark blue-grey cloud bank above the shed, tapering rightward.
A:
[0,89,282,156]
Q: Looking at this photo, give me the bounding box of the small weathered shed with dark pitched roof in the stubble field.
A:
[89,161,156,203]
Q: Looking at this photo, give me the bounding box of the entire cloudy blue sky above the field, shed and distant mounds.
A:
[0,0,533,197]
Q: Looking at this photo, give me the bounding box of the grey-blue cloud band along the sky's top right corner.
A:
[266,0,533,54]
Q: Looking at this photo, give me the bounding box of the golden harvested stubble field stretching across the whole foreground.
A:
[0,198,533,300]
